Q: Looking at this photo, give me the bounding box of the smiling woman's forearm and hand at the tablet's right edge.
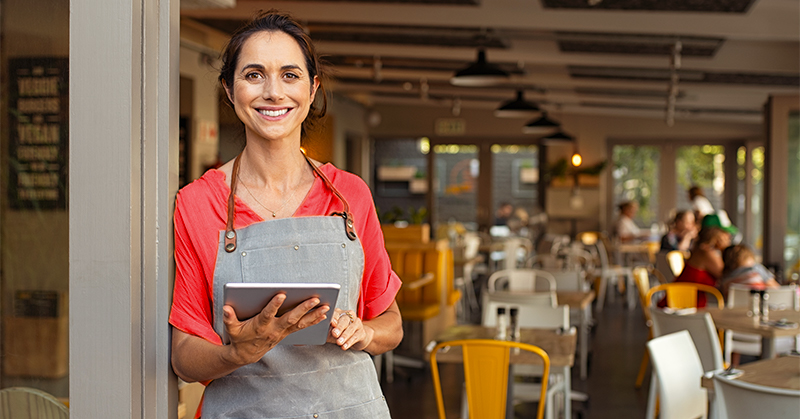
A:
[328,301,403,355]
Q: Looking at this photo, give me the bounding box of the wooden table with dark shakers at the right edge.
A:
[705,307,800,359]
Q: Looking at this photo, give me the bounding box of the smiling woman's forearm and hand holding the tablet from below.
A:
[172,294,330,382]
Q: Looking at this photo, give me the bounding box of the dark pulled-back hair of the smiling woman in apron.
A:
[219,9,328,139]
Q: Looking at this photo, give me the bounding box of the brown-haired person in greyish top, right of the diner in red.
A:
[720,244,780,295]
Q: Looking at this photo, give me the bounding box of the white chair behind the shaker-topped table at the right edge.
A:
[724,284,800,364]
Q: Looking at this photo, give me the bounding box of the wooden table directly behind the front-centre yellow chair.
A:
[431,325,577,419]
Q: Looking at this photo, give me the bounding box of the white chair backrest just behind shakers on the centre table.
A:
[481,294,570,330]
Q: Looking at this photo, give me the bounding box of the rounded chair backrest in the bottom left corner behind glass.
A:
[0,387,69,419]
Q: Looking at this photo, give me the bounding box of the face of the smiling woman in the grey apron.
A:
[225,31,319,141]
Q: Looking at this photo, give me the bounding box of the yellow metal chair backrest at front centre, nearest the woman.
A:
[430,339,550,419]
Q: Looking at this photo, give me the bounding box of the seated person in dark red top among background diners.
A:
[675,227,731,308]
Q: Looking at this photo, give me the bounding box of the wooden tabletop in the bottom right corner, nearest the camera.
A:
[703,355,800,390]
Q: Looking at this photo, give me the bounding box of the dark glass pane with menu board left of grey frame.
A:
[0,0,70,399]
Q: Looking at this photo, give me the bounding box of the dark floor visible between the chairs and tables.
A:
[382,298,649,419]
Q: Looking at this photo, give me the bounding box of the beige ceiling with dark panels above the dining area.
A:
[182,0,800,123]
